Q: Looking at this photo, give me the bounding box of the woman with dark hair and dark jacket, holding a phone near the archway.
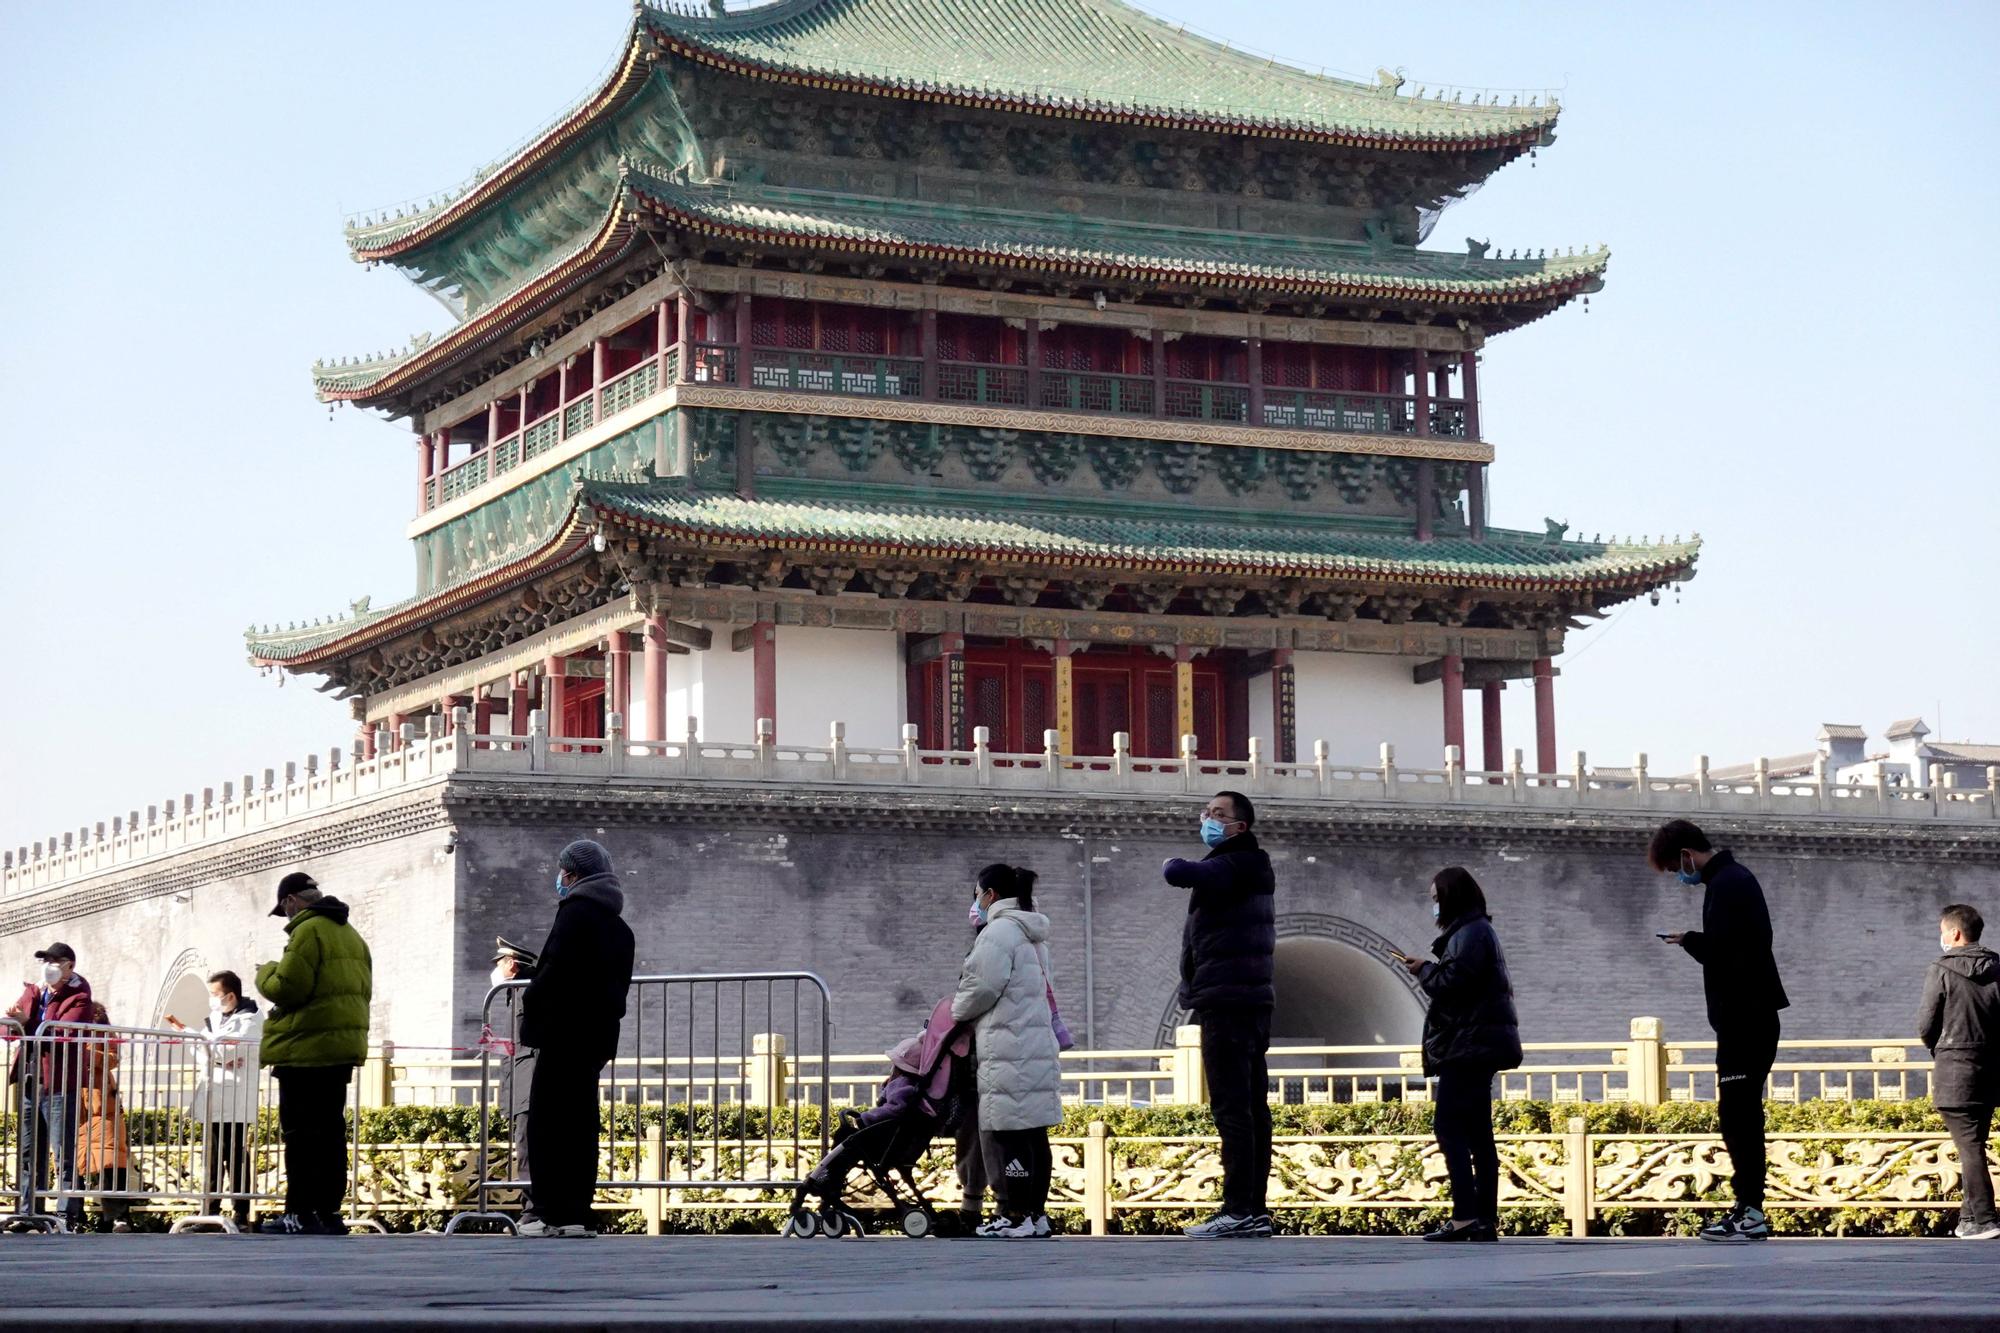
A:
[1400,865,1520,1241]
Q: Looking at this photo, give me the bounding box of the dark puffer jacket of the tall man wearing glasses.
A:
[1162,831,1278,1013]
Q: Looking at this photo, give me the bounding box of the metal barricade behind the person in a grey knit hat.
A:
[446,973,834,1233]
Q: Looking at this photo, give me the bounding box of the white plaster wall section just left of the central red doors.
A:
[772,624,908,751]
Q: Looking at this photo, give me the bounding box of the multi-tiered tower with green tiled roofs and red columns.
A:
[248,0,1698,773]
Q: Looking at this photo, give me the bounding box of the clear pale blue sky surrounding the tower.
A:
[0,0,2000,847]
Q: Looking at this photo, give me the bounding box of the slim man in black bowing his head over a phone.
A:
[1646,819,1792,1241]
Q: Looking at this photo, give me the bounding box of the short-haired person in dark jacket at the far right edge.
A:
[1916,903,2000,1241]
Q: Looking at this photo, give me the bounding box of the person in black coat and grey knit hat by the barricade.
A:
[520,839,634,1237]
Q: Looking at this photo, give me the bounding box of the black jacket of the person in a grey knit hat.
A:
[520,873,634,1065]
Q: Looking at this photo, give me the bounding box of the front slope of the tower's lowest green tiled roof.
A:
[580,480,1700,588]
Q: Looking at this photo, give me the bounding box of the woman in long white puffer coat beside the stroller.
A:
[952,865,1062,1241]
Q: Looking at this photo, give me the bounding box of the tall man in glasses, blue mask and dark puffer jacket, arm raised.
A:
[1160,791,1278,1241]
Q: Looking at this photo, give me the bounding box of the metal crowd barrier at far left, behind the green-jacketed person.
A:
[0,1023,382,1233]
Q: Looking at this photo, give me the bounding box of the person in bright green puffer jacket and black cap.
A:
[256,871,374,1235]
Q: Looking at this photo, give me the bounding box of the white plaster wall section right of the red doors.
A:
[1296,650,1440,769]
